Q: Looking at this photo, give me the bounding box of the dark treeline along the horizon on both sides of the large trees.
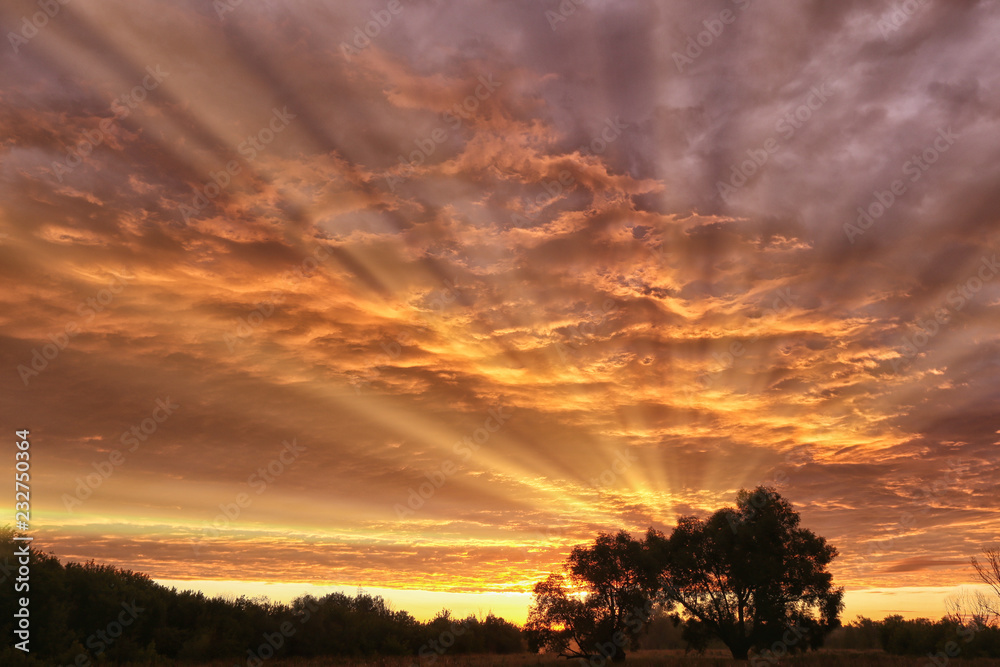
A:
[0,530,1000,667]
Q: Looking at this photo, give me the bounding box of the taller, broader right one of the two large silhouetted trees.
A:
[647,486,843,660]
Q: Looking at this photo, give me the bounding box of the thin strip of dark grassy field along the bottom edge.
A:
[195,651,1000,667]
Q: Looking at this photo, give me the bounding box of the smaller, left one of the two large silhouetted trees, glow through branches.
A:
[525,531,658,662]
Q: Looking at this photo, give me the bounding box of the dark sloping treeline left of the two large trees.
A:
[0,530,525,667]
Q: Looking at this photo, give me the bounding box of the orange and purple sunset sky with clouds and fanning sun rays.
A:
[0,0,1000,621]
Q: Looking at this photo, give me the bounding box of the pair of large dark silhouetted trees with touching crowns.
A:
[526,487,843,661]
